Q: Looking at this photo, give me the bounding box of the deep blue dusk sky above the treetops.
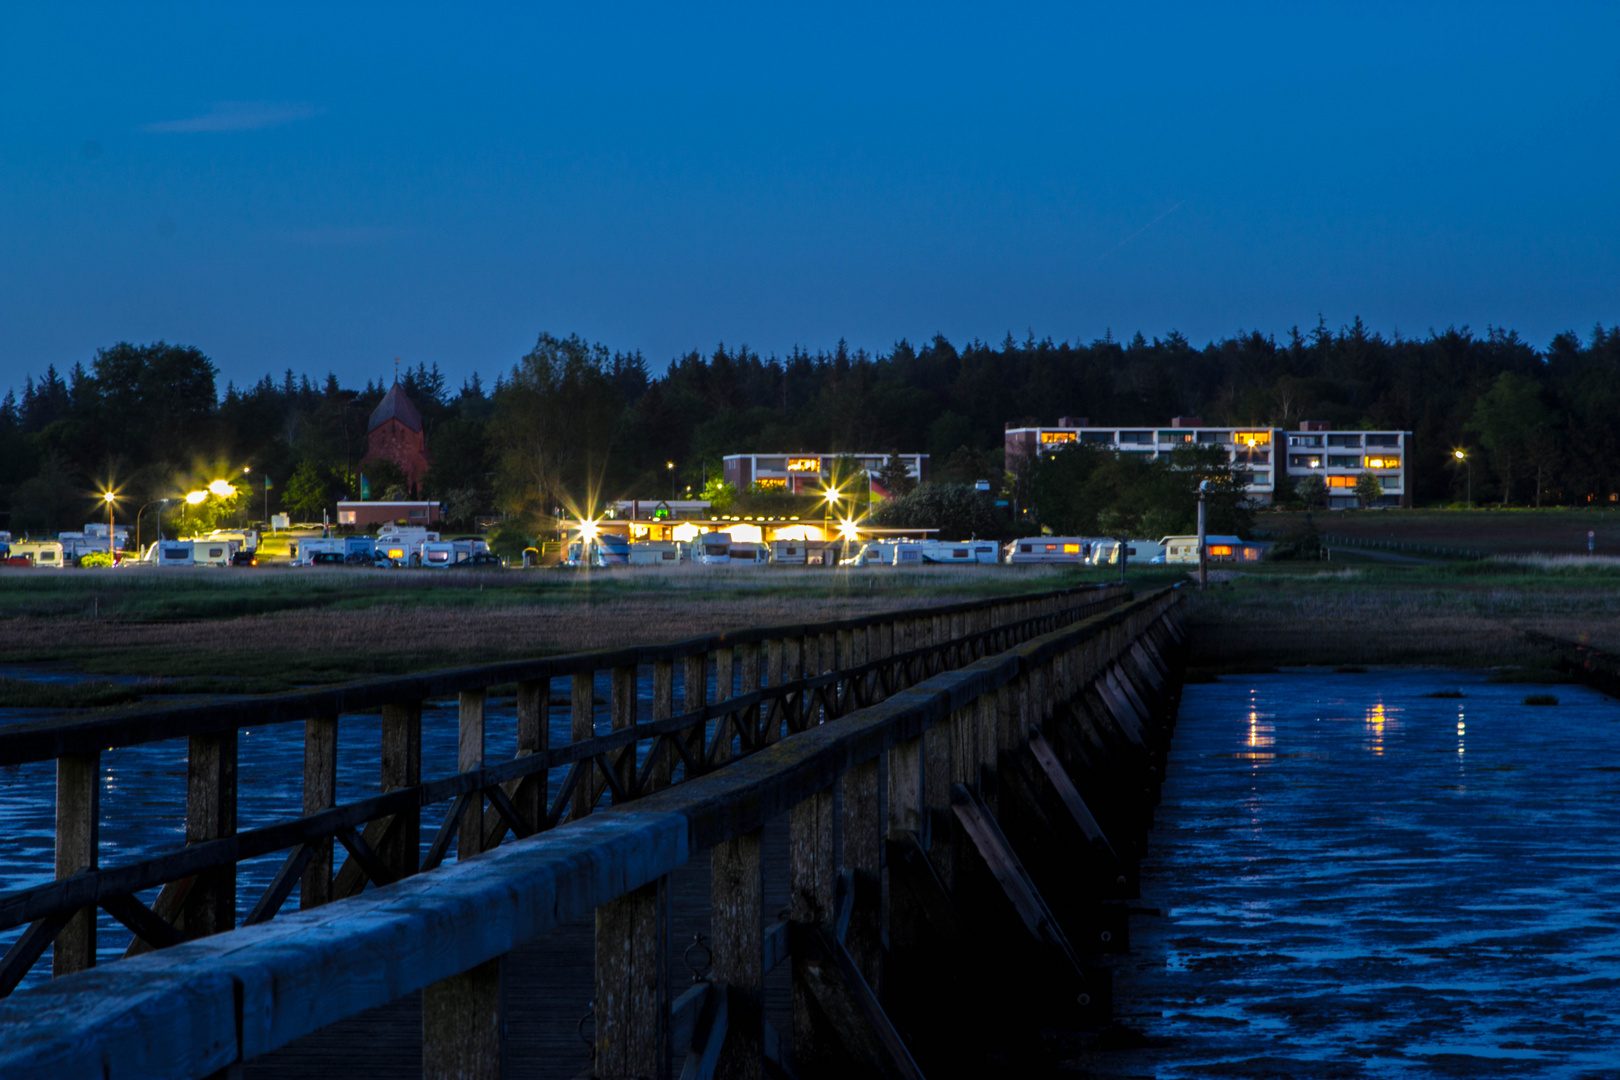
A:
[0,3,1620,390]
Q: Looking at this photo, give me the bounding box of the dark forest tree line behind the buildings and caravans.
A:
[0,319,1620,533]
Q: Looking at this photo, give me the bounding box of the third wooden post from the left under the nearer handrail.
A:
[710,835,765,1080]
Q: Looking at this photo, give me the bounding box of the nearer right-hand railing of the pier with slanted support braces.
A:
[0,589,1183,1080]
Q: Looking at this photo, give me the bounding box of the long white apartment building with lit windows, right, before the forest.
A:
[1006,416,1411,510]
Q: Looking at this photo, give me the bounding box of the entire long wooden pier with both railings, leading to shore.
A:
[0,588,1183,1080]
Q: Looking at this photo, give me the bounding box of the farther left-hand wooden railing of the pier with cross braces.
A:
[0,586,1123,996]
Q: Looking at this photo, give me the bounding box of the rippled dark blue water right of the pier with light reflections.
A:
[1095,670,1620,1077]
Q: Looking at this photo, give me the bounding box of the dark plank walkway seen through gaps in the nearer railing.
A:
[245,818,792,1080]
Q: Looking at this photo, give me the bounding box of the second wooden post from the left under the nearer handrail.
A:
[595,878,671,1077]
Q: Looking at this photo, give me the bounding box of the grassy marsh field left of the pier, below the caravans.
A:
[0,565,1108,704]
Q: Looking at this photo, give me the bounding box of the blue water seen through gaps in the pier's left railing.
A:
[0,669,729,988]
